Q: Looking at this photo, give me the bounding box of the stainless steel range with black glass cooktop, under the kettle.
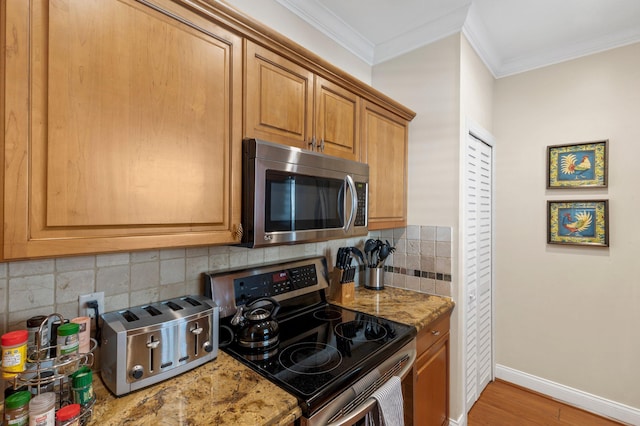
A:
[205,257,416,426]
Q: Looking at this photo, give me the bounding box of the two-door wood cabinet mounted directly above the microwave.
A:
[244,41,360,160]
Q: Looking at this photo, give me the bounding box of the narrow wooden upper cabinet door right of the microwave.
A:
[361,102,408,230]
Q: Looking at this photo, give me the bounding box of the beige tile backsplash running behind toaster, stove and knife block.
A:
[0,226,451,333]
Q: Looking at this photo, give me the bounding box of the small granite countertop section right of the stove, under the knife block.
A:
[332,287,454,331]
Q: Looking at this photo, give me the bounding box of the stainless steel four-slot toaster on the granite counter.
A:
[100,295,219,395]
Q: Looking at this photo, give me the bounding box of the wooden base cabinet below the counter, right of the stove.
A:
[403,314,449,426]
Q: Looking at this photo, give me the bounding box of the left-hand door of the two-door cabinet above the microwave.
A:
[244,41,313,149]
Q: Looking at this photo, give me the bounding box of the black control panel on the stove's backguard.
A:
[233,264,318,305]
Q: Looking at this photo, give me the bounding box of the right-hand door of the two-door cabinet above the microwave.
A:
[314,77,360,161]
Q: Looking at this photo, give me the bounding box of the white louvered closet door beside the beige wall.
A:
[463,134,493,411]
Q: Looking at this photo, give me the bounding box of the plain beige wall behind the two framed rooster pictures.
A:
[493,44,640,408]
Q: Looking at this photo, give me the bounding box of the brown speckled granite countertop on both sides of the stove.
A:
[82,287,454,426]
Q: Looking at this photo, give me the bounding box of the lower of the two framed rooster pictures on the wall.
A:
[547,200,609,247]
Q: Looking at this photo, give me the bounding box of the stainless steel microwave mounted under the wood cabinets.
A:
[241,139,369,247]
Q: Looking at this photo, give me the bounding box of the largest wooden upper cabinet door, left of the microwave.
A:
[3,0,242,259]
